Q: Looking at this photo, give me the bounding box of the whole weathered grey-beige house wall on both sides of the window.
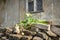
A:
[0,0,60,26]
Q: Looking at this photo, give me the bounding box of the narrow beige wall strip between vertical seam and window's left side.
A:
[19,0,26,21]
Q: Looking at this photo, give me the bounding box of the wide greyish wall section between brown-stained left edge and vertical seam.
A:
[2,0,20,27]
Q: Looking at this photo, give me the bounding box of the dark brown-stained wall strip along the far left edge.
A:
[0,0,5,26]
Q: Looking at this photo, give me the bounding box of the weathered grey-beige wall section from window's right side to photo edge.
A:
[42,0,60,25]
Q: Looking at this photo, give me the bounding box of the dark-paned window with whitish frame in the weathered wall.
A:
[26,0,43,12]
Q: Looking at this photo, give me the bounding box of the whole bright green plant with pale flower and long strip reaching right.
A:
[19,13,48,29]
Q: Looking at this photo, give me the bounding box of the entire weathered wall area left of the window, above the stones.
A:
[0,0,25,27]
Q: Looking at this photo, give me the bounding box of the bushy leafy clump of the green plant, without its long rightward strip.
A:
[19,13,36,29]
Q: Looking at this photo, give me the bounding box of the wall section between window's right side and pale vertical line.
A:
[41,0,53,20]
